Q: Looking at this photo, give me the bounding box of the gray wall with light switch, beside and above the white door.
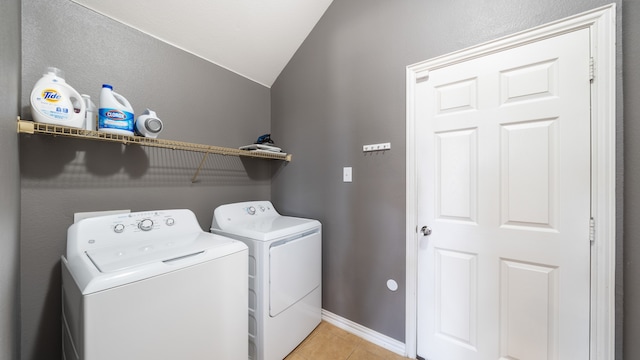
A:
[271,0,624,348]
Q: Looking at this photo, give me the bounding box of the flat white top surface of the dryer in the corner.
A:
[219,216,320,241]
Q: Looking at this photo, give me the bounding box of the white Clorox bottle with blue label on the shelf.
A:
[98,84,134,136]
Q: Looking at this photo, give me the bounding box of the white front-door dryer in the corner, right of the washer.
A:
[211,201,322,360]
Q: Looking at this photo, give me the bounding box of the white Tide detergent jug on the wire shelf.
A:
[30,67,86,128]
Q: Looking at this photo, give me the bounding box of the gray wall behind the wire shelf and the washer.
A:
[18,0,274,360]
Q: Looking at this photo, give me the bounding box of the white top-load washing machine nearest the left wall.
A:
[62,210,248,360]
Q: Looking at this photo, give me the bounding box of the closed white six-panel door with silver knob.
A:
[415,29,591,360]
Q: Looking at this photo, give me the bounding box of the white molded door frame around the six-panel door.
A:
[405,4,616,360]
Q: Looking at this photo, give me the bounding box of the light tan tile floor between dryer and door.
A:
[285,321,407,360]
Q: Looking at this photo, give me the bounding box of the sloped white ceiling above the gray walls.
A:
[72,0,333,87]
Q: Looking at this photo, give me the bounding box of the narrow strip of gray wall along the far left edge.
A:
[0,0,20,360]
